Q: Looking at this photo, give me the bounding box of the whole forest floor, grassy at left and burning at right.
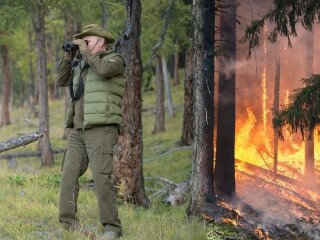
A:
[0,81,320,240]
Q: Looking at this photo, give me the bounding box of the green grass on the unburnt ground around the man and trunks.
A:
[0,79,214,240]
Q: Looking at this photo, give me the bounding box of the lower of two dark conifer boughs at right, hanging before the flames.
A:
[273,74,320,139]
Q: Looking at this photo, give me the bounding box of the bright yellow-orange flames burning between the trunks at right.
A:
[235,108,320,178]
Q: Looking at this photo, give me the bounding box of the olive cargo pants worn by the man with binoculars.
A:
[59,126,121,233]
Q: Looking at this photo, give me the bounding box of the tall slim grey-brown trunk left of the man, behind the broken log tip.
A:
[33,1,54,166]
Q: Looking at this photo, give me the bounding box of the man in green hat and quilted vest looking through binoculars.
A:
[57,24,125,240]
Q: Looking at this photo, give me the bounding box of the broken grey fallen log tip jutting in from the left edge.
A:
[0,130,47,152]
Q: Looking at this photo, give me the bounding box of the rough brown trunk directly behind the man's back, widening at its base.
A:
[114,0,149,207]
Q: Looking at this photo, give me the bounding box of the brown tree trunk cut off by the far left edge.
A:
[1,43,10,125]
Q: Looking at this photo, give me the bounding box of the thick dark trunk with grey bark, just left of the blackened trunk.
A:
[187,0,216,216]
